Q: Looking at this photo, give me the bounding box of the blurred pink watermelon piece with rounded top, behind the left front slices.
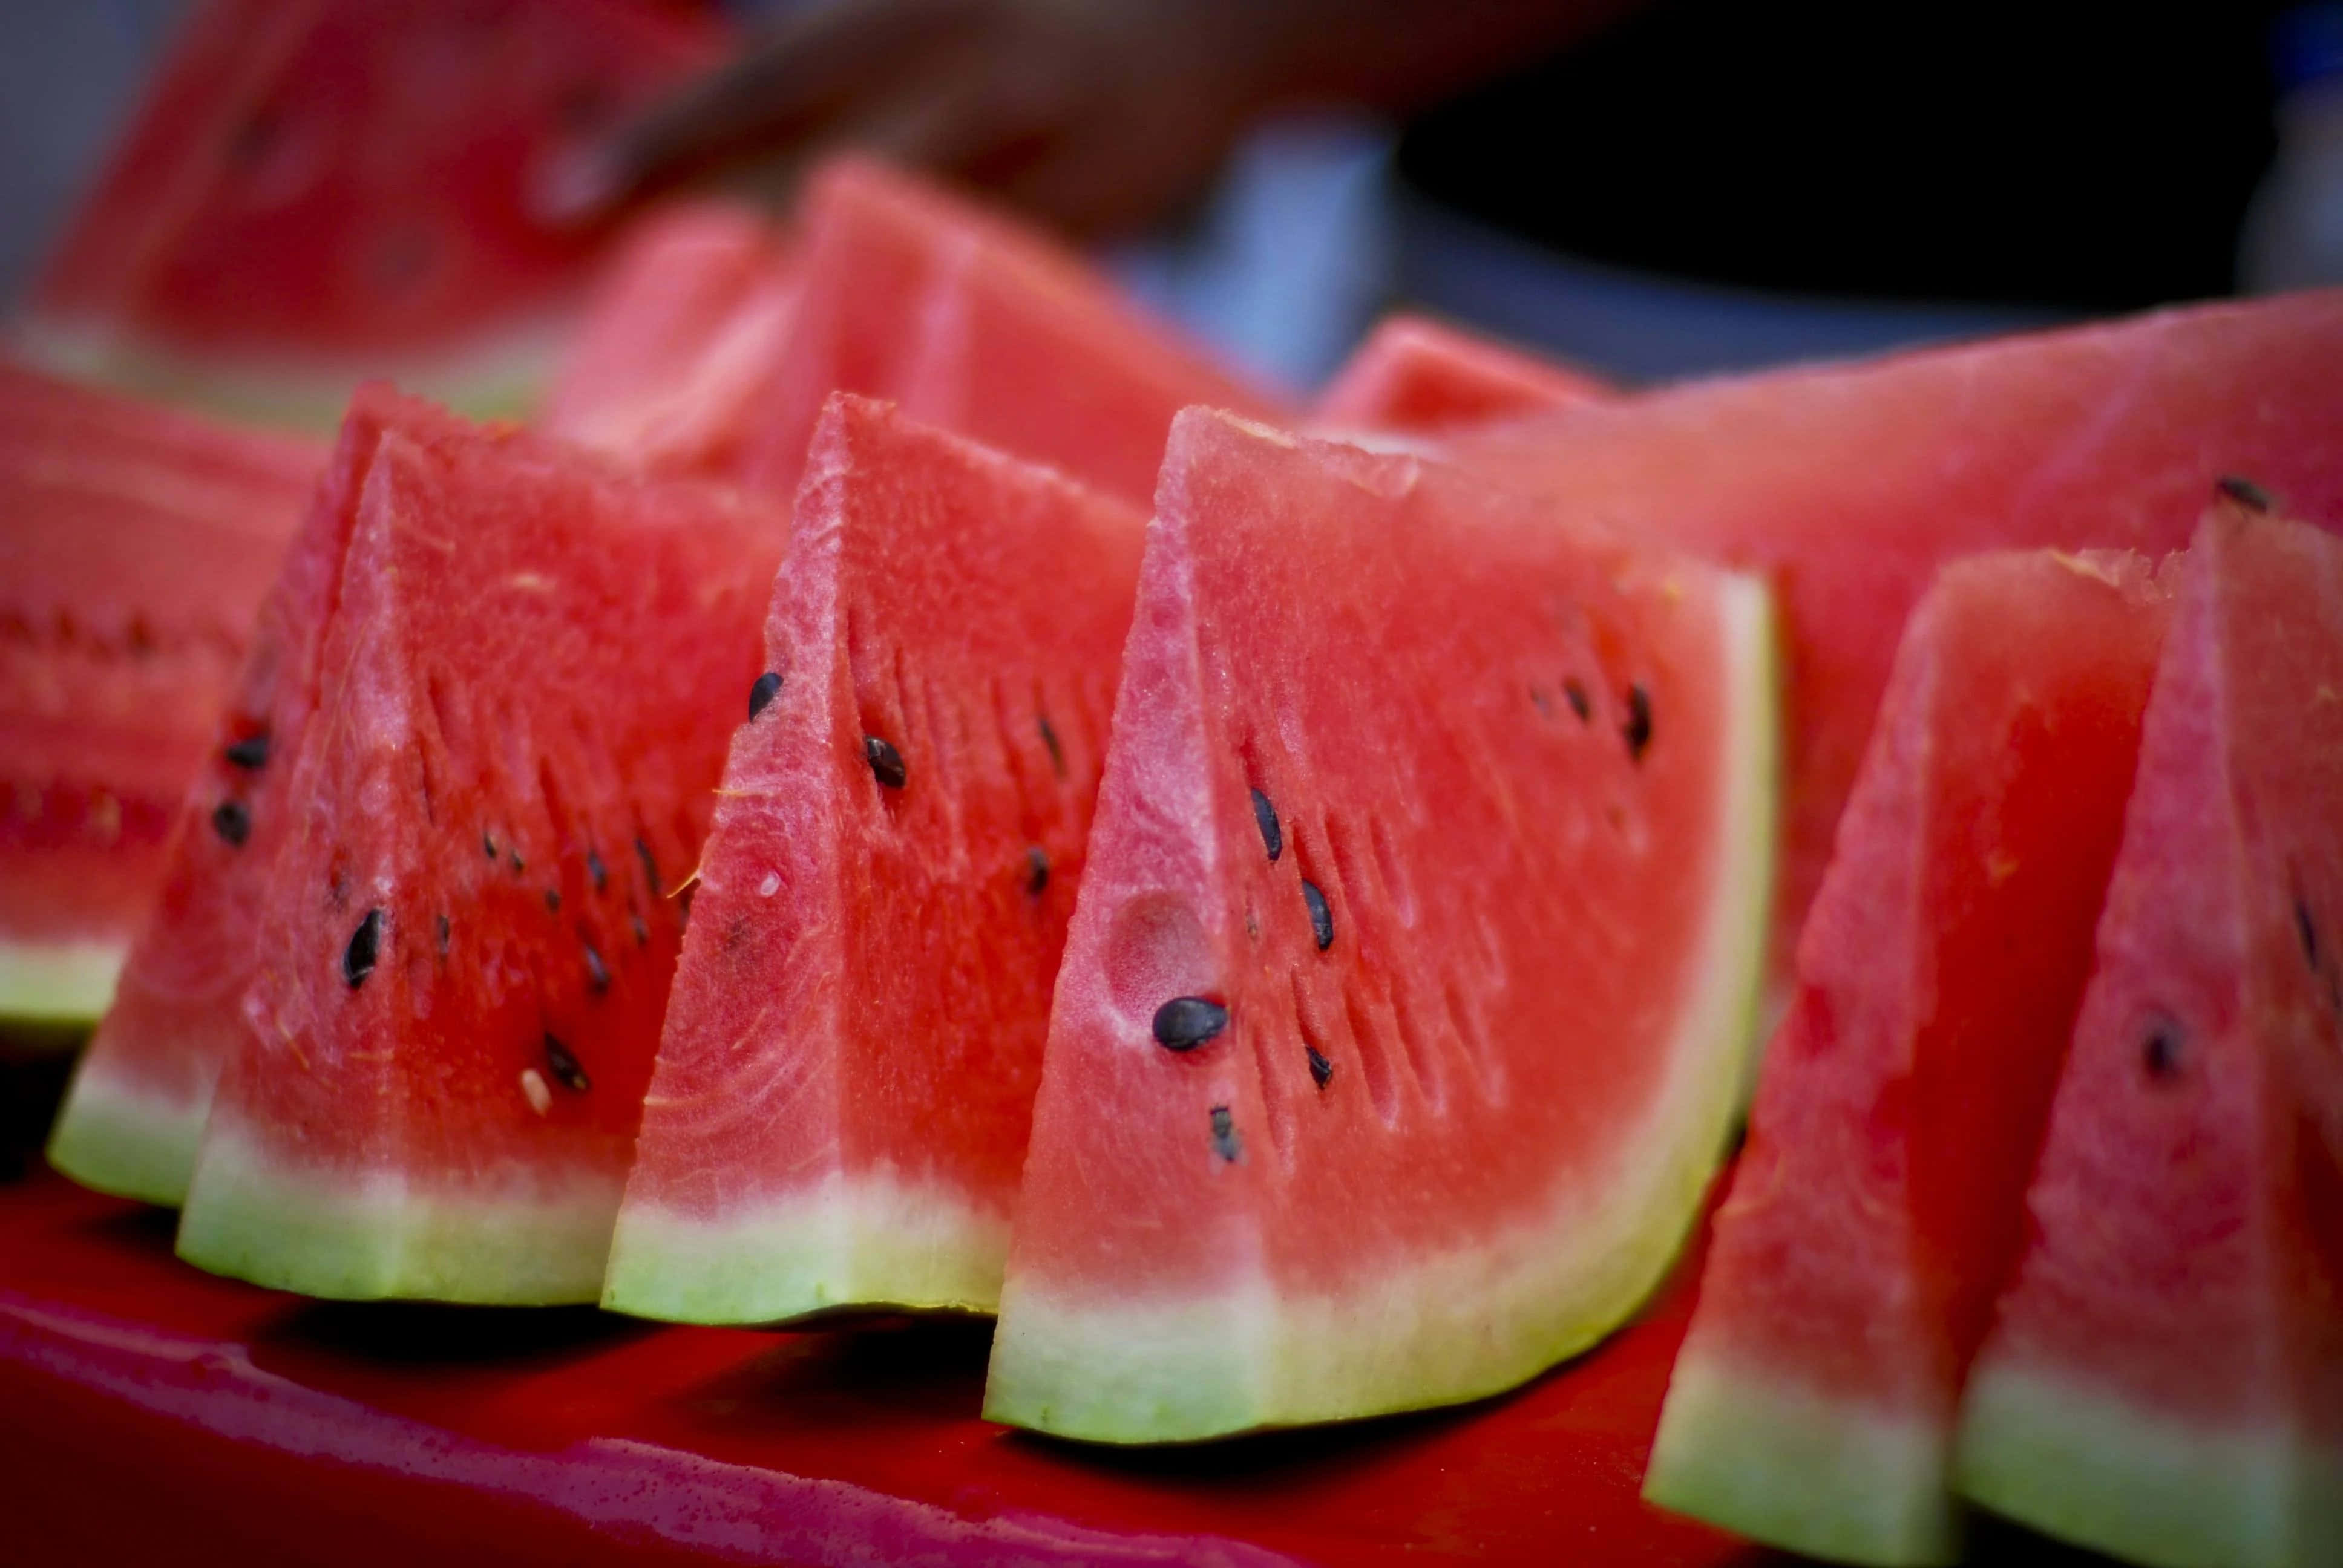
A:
[537,201,796,474]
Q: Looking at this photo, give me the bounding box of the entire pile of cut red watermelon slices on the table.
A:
[18,0,2343,1563]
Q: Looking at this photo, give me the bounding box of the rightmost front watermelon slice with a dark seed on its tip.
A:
[1959,509,2343,1568]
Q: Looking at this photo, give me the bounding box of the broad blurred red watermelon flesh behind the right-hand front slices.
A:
[1453,290,2343,1003]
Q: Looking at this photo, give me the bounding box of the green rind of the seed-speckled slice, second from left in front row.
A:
[178,1118,618,1305]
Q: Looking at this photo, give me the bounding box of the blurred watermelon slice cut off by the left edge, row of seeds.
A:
[0,364,323,1024]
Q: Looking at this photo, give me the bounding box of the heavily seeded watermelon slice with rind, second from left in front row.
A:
[178,393,778,1301]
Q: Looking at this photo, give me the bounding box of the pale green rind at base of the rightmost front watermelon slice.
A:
[1954,1364,2343,1568]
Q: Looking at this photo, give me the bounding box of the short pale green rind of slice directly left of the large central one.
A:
[602,1172,1010,1324]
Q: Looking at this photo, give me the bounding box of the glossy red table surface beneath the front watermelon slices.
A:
[0,1129,2108,1568]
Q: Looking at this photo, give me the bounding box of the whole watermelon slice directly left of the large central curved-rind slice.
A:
[602,396,1145,1322]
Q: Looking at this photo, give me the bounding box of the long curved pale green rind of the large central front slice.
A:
[984,577,1781,1444]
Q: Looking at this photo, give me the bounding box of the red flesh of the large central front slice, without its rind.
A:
[1010,410,1727,1313]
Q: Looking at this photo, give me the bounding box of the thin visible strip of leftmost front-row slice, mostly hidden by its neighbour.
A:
[49,387,468,1204]
